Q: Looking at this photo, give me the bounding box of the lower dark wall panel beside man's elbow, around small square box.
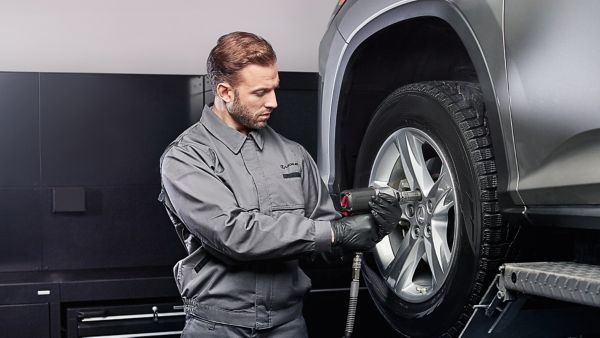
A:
[42,186,185,270]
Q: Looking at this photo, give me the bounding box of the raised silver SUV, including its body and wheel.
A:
[318,0,600,337]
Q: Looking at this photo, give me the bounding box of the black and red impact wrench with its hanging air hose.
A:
[340,187,422,338]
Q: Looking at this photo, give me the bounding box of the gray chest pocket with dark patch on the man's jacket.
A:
[267,161,305,215]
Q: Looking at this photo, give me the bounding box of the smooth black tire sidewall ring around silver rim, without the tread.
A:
[354,92,481,336]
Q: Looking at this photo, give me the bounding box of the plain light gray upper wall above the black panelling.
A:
[0,0,337,75]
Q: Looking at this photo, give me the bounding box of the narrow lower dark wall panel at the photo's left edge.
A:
[0,189,42,272]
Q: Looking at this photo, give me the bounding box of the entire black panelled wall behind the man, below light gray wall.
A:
[0,72,317,272]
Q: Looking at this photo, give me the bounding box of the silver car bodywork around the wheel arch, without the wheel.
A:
[318,0,600,212]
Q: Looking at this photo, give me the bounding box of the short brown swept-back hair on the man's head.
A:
[206,32,277,94]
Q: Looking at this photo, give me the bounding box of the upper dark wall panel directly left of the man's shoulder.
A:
[40,74,190,186]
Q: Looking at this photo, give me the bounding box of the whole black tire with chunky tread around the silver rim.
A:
[354,81,507,337]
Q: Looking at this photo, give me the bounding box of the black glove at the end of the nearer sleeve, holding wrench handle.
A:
[331,214,381,253]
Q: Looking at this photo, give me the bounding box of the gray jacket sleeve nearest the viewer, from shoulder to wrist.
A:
[161,146,331,262]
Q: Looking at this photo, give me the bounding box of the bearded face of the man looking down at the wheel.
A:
[227,65,279,131]
